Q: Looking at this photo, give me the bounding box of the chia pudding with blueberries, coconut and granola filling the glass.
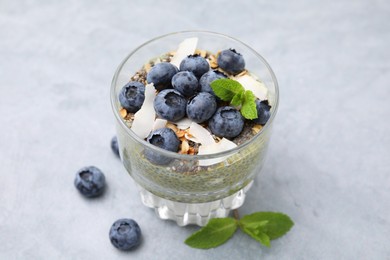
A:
[113,34,277,203]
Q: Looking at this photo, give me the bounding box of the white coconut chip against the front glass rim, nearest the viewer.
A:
[198,138,237,166]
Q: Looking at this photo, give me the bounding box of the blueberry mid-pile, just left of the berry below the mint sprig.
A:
[187,92,217,123]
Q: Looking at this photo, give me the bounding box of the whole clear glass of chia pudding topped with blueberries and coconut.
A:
[111,31,278,226]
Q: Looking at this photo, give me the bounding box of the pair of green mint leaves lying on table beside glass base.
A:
[185,212,294,249]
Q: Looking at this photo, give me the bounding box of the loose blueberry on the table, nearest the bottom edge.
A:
[109,218,141,250]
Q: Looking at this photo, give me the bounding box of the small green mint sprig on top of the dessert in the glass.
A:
[210,79,258,120]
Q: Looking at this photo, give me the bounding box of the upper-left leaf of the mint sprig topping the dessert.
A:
[210,79,245,101]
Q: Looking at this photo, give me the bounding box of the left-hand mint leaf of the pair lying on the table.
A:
[184,218,238,249]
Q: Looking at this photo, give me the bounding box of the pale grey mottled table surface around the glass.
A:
[0,0,390,259]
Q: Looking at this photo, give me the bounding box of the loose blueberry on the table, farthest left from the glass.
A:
[74,166,106,198]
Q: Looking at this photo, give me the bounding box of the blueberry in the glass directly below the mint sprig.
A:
[209,106,244,138]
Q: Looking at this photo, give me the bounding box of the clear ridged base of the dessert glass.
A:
[139,181,253,226]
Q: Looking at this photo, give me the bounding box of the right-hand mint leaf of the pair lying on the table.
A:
[239,212,294,240]
